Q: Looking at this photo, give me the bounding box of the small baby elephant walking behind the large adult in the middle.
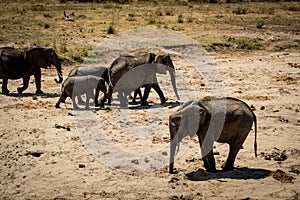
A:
[55,75,106,109]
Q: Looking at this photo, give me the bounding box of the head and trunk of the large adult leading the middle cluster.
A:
[154,54,180,100]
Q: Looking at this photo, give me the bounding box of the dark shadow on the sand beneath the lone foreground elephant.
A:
[186,167,271,182]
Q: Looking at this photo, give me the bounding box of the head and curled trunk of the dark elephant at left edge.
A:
[44,48,63,83]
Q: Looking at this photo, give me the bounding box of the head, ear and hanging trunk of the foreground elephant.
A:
[169,101,207,173]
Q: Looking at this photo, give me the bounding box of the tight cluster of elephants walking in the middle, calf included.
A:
[56,53,179,108]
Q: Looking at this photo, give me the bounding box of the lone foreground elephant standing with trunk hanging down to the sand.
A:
[169,97,257,173]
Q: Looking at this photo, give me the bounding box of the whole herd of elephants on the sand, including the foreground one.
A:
[0,47,257,173]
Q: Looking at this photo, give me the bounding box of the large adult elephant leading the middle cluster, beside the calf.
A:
[95,53,179,106]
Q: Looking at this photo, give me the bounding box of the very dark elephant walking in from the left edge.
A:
[0,47,63,95]
